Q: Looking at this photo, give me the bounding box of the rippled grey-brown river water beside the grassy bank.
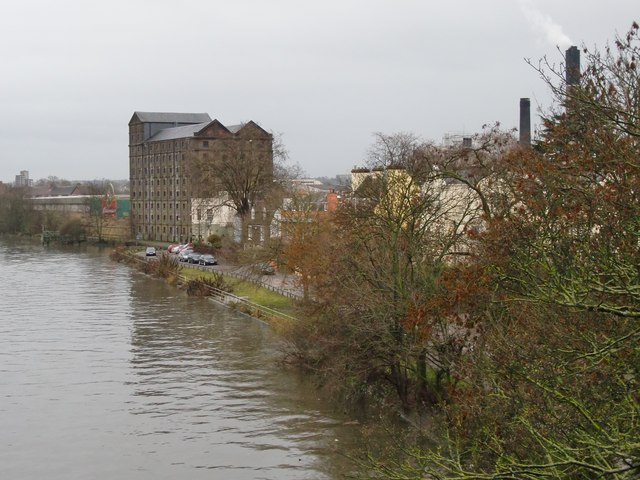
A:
[0,239,372,480]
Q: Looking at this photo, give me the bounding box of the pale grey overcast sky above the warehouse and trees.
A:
[0,0,640,182]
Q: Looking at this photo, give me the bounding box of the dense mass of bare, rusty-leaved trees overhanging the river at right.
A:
[283,23,640,479]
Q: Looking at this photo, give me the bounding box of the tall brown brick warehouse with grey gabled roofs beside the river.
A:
[129,112,273,242]
